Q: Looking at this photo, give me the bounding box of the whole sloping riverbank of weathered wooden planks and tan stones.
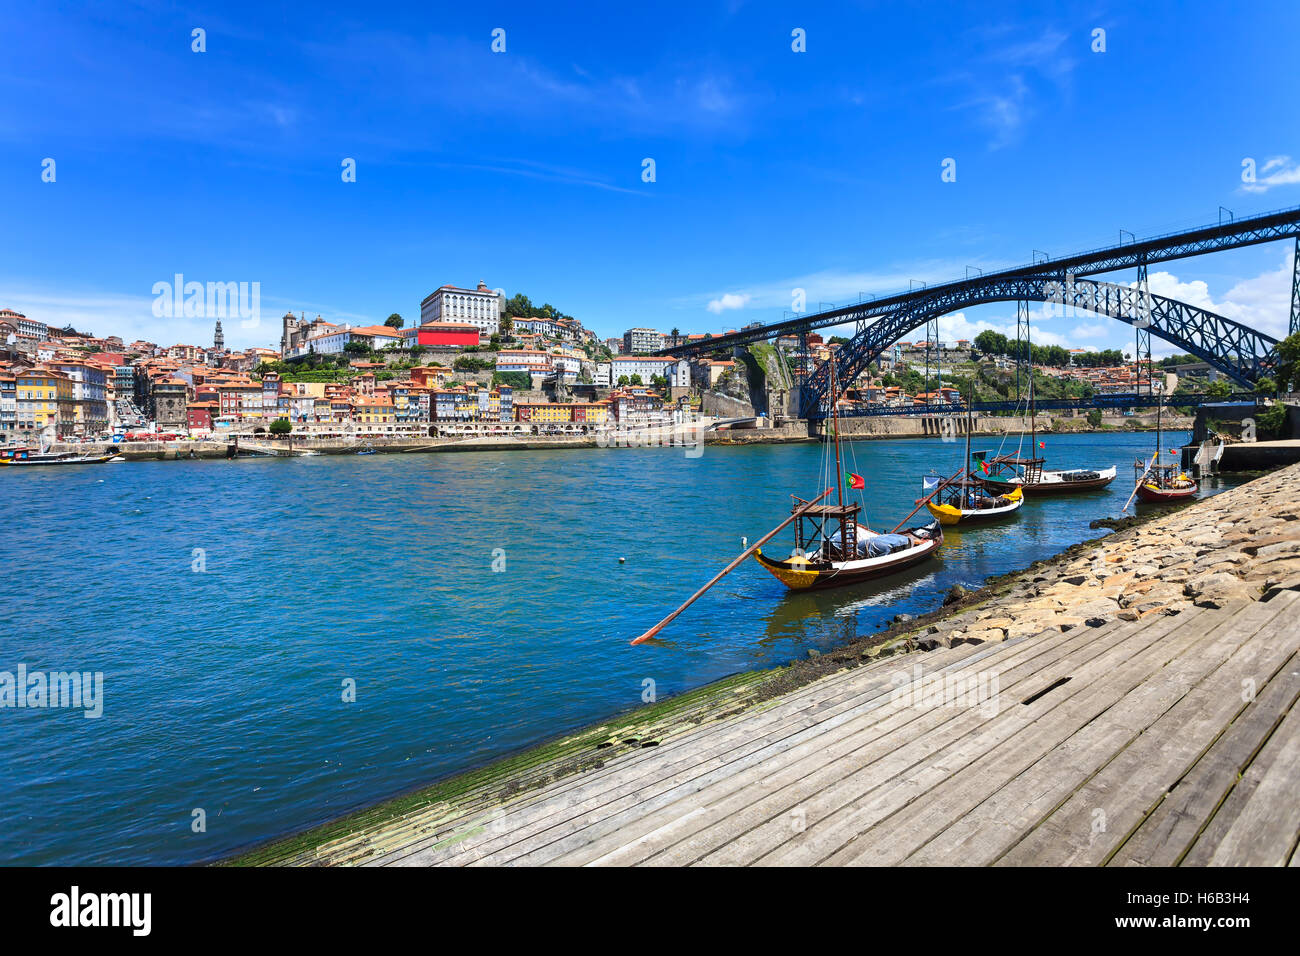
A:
[231,466,1300,866]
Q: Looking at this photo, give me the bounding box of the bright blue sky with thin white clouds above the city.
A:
[0,0,1300,356]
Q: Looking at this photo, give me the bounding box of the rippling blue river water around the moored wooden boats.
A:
[0,434,1221,864]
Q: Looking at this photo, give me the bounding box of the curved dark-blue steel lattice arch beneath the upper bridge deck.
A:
[802,276,1278,418]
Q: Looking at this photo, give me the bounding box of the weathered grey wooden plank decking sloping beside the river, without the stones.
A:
[332,591,1300,865]
